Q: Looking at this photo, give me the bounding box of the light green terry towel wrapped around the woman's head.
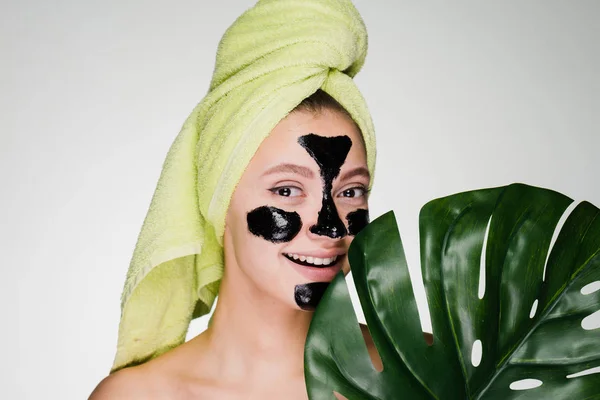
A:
[112,0,375,372]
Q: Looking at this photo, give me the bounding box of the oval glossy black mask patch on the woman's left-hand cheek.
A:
[246,206,302,243]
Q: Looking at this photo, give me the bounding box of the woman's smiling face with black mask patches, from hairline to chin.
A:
[225,110,369,310]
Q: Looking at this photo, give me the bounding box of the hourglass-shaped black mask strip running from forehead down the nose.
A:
[298,133,352,239]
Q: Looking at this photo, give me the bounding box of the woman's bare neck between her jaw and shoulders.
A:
[189,270,312,385]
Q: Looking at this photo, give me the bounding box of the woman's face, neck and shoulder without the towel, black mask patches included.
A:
[92,90,381,399]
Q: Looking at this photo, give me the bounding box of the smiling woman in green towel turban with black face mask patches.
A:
[91,0,381,400]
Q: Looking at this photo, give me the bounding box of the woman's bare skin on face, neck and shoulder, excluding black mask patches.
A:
[90,110,390,400]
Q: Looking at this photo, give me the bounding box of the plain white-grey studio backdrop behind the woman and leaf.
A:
[0,0,600,399]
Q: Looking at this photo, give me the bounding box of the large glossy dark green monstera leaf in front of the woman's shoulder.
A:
[305,184,600,400]
